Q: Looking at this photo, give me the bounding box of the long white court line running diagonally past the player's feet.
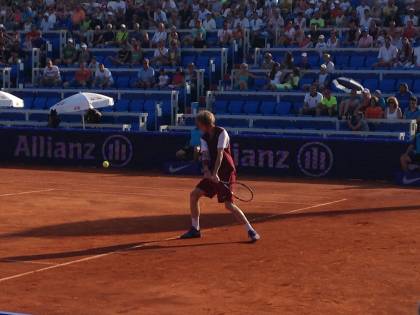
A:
[0,198,347,283]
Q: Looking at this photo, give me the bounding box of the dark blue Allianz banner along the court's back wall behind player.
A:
[0,128,408,179]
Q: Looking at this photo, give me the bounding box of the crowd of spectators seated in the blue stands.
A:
[0,0,420,123]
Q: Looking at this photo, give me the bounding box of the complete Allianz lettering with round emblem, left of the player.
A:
[14,135,133,167]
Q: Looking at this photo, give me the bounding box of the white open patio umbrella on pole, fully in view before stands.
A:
[50,92,114,129]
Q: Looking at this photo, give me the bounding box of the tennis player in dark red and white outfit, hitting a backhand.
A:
[181,111,260,242]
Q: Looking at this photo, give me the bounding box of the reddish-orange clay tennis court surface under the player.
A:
[0,169,420,314]
